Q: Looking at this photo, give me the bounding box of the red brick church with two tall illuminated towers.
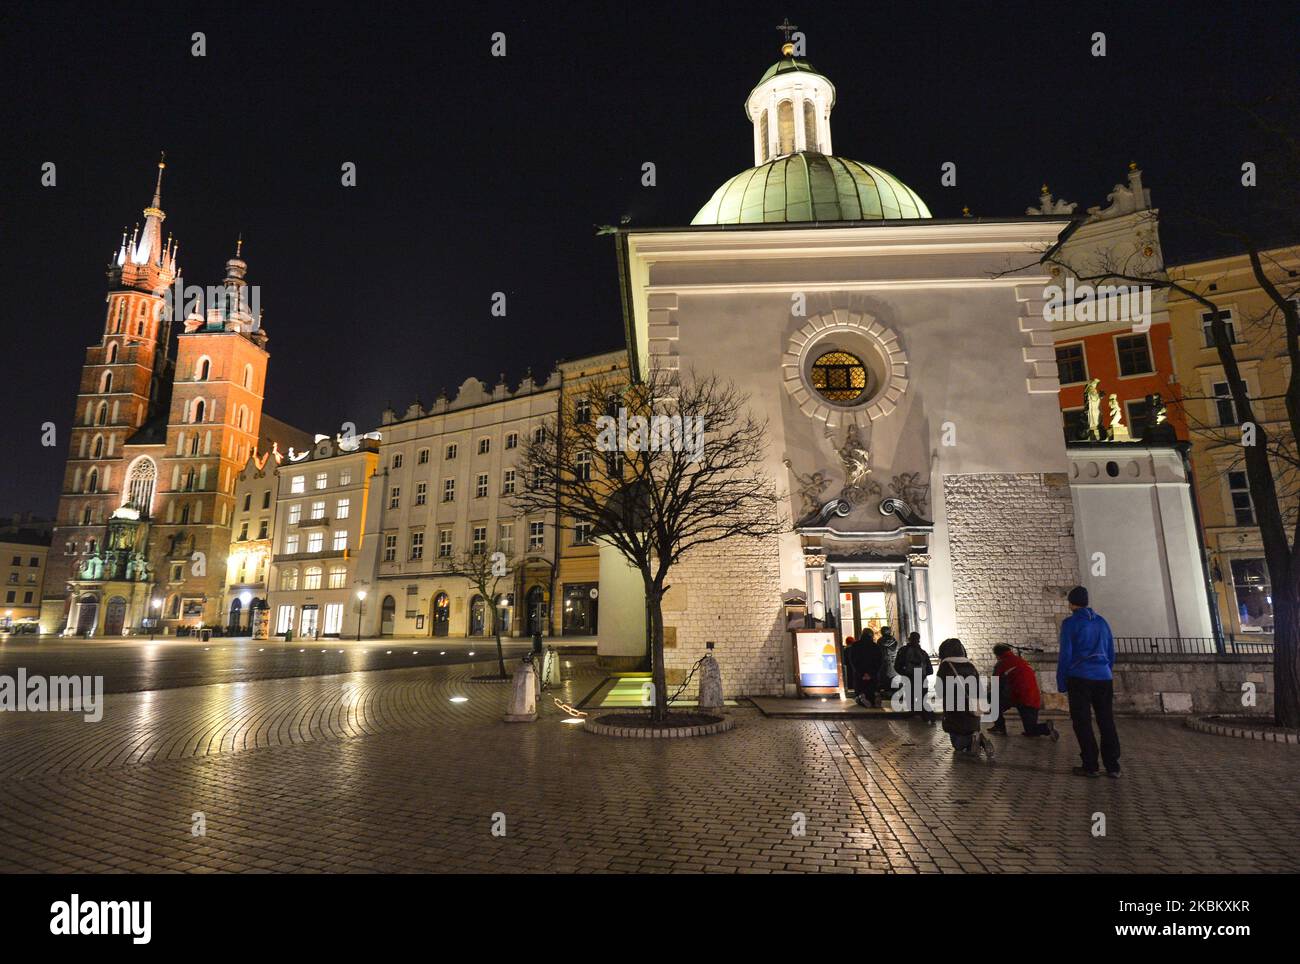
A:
[42,161,269,637]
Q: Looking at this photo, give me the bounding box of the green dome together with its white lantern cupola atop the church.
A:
[690,43,931,225]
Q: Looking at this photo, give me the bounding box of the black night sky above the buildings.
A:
[0,0,1297,516]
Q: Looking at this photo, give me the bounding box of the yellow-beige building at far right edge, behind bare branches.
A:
[1169,247,1300,641]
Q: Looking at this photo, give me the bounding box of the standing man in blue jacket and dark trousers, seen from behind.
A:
[1057,586,1119,778]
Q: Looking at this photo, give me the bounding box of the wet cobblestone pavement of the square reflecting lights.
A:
[0,657,1300,873]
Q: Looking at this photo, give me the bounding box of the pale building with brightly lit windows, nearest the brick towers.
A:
[268,434,380,639]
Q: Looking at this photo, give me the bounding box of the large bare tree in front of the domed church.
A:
[514,369,788,721]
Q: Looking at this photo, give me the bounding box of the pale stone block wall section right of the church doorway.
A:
[936,473,1079,660]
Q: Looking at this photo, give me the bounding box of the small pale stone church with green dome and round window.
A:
[599,35,1209,695]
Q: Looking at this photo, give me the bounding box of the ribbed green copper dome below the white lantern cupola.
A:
[690,152,931,225]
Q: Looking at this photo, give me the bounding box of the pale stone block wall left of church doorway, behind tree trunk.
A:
[663,538,789,696]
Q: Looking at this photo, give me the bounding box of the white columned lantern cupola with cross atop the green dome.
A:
[745,34,835,166]
